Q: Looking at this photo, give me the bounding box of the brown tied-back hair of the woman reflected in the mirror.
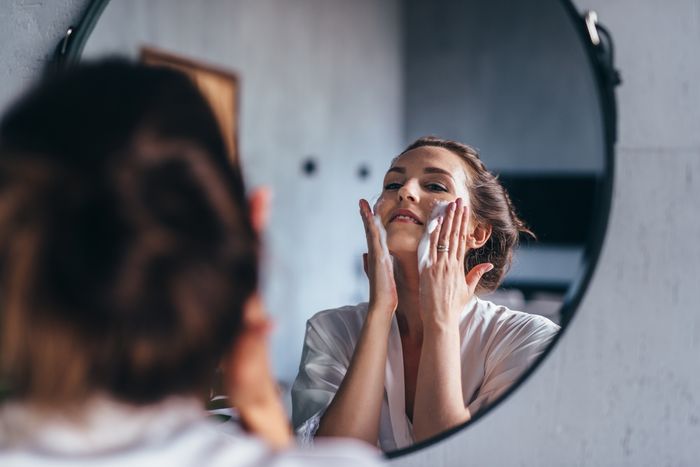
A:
[401,136,534,293]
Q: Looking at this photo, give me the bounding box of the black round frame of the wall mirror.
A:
[52,0,621,459]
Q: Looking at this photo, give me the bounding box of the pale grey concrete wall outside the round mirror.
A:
[0,0,700,467]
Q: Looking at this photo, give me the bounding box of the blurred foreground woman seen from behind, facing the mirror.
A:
[0,61,377,466]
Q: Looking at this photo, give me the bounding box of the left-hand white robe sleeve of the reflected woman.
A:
[292,320,352,445]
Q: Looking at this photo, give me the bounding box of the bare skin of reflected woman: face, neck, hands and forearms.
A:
[317,146,493,444]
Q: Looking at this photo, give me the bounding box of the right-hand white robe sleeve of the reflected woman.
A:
[468,313,559,416]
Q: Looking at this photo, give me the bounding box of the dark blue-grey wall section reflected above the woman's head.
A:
[404,0,604,175]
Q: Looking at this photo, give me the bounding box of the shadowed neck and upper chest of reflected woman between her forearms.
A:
[393,252,423,344]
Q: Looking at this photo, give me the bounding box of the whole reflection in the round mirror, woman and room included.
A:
[84,0,604,451]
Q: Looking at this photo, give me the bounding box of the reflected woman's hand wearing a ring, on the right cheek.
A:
[419,198,493,327]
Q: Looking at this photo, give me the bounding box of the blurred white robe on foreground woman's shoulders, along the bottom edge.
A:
[0,398,383,467]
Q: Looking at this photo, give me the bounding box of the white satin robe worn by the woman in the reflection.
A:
[292,297,559,451]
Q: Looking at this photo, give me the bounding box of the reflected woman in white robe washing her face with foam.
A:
[292,137,559,451]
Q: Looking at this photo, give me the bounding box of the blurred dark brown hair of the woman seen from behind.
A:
[0,60,258,408]
